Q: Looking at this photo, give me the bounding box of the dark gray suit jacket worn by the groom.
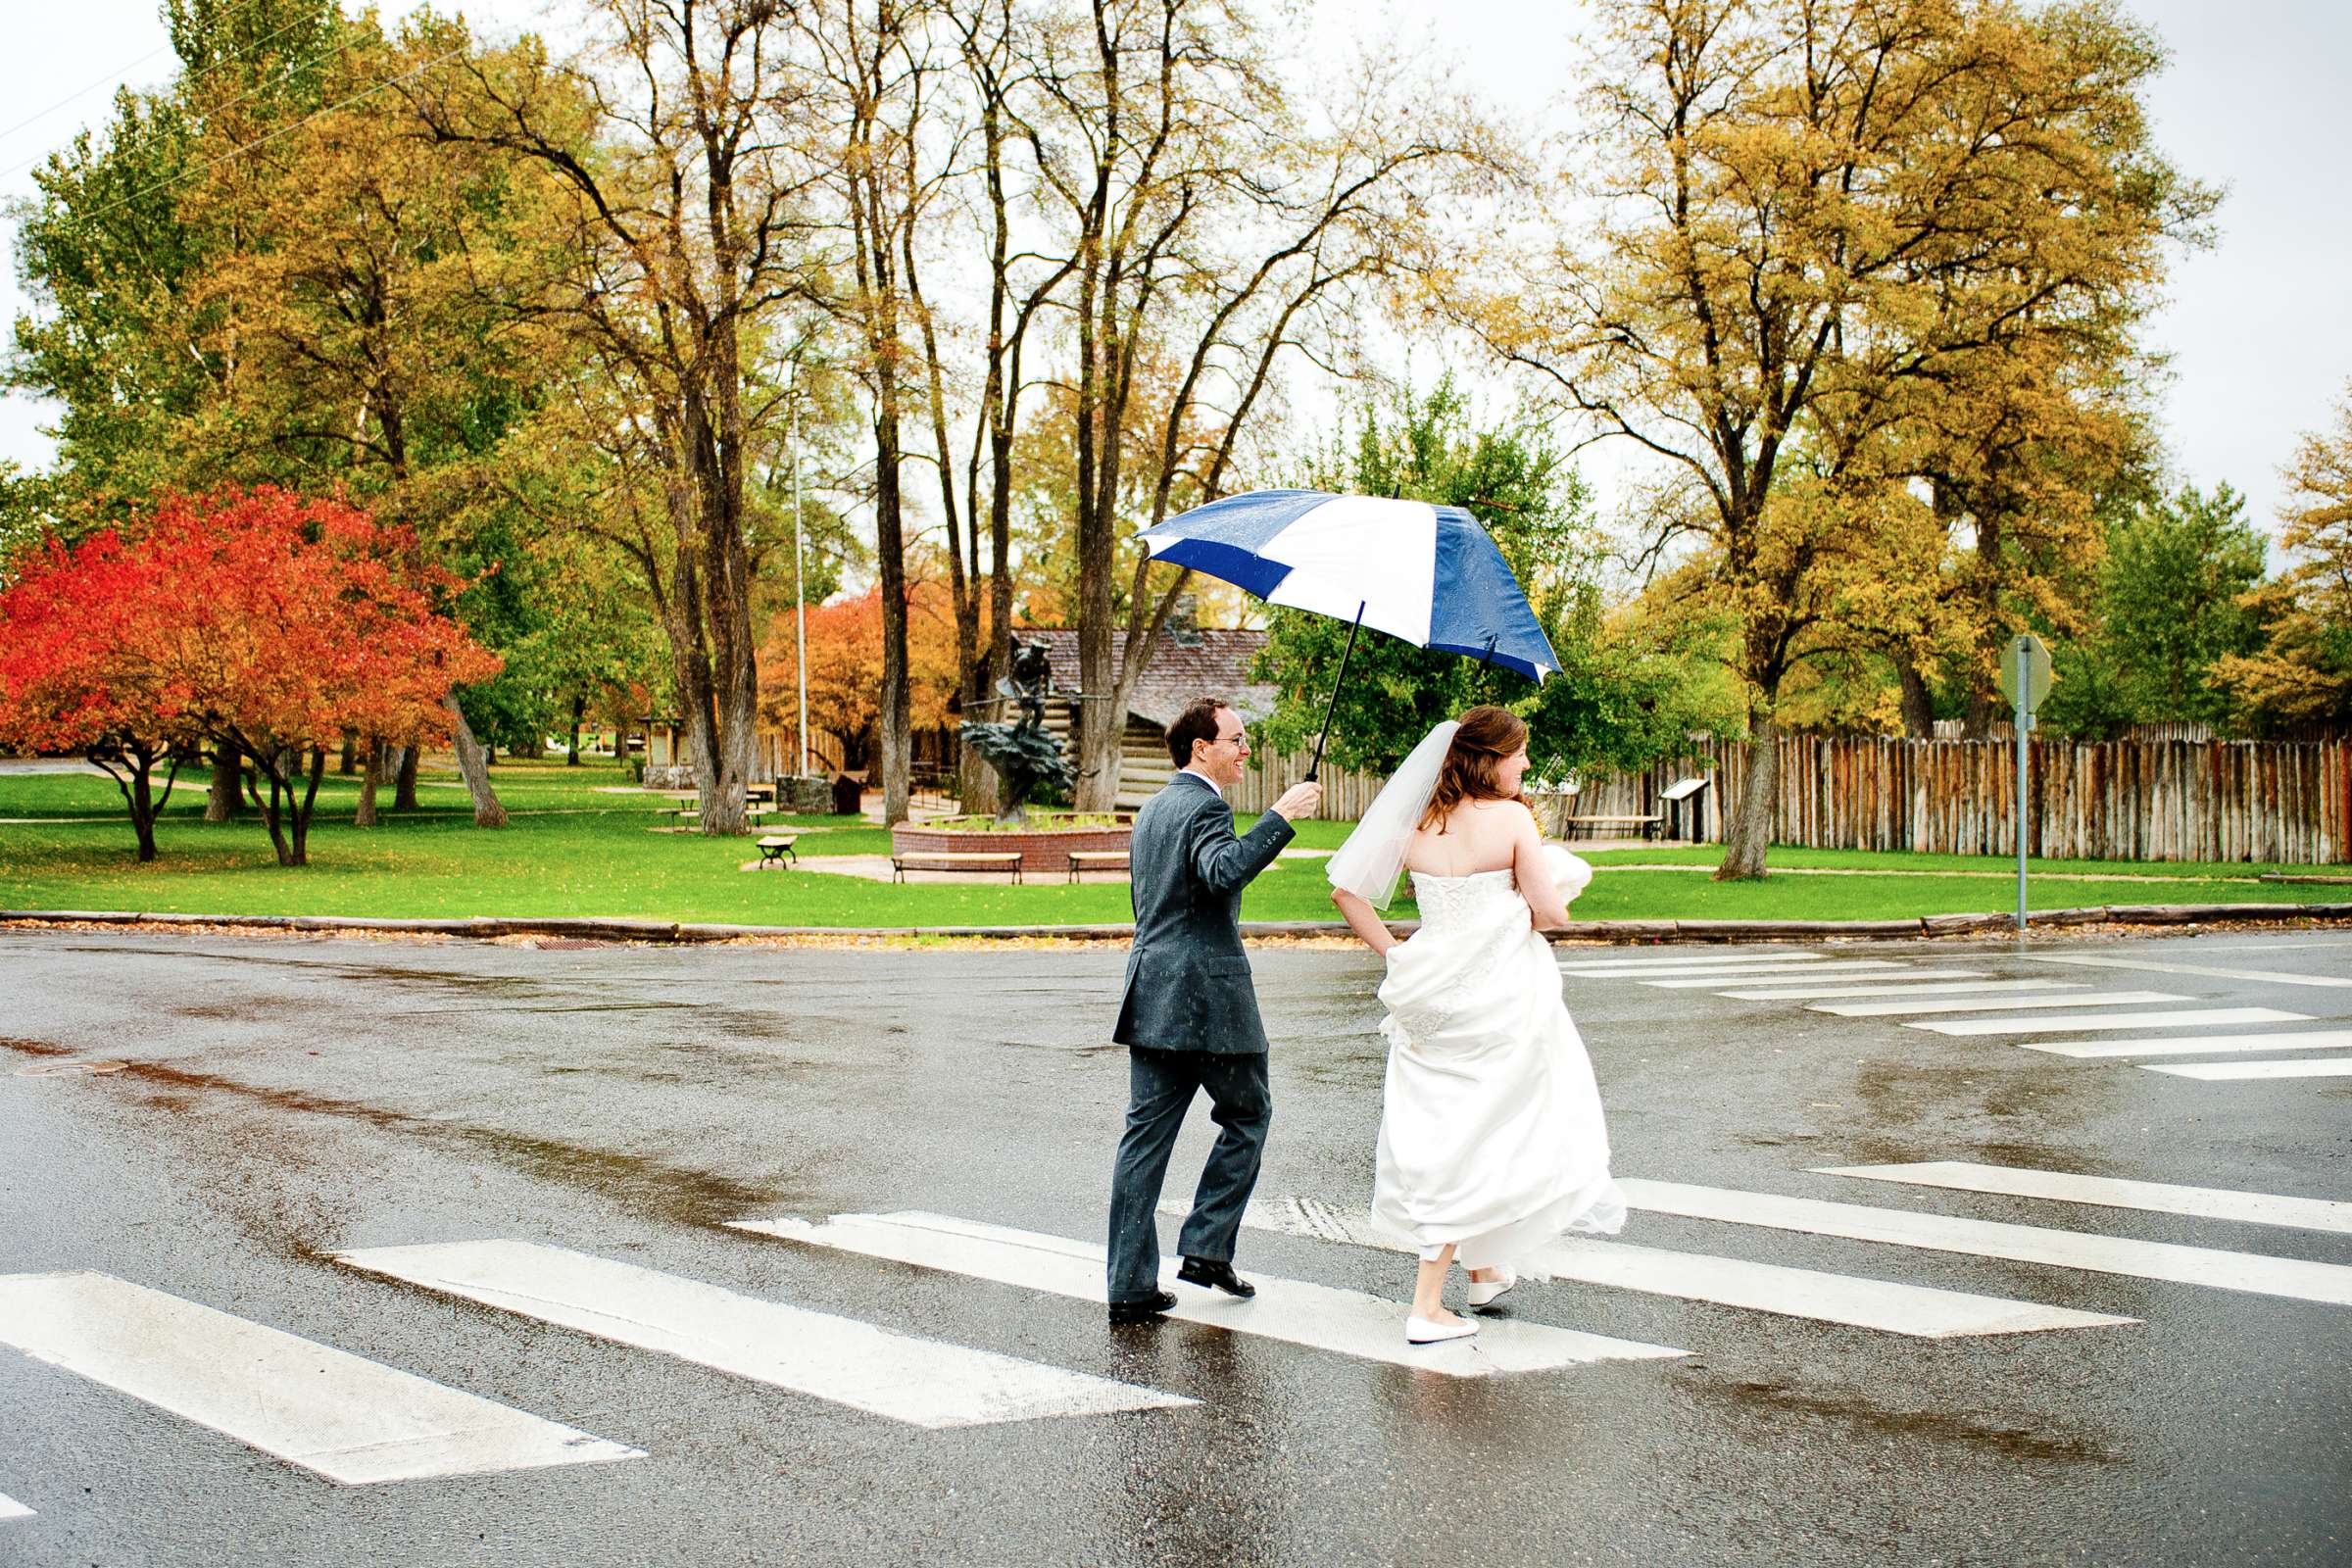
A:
[1112,773,1298,1055]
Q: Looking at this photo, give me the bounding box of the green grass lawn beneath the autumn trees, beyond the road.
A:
[0,761,2352,926]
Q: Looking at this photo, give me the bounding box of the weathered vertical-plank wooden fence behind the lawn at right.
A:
[1233,736,2352,865]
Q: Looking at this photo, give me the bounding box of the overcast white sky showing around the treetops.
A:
[0,0,2352,540]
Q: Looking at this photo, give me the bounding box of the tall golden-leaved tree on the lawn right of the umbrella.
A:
[1456,0,2201,877]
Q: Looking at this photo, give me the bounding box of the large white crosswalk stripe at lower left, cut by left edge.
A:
[0,1274,642,1486]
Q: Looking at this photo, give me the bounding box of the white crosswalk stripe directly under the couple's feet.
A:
[731,1213,1689,1378]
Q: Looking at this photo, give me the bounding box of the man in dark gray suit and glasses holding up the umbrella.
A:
[1107,698,1322,1324]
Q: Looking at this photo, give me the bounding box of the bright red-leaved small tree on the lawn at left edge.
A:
[0,489,499,865]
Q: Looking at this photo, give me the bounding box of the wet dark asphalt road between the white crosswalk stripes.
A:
[0,931,2352,1568]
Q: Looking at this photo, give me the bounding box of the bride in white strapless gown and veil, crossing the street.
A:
[1329,708,1625,1345]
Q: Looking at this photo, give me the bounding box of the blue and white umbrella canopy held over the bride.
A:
[1141,489,1559,682]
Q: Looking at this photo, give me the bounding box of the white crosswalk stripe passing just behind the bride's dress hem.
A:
[1213,1197,2138,1340]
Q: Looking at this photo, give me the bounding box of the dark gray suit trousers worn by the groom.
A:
[1107,1046,1275,1302]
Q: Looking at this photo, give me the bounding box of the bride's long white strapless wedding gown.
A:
[1371,844,1625,1277]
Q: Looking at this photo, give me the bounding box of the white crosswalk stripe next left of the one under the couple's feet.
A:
[336,1242,1176,1427]
